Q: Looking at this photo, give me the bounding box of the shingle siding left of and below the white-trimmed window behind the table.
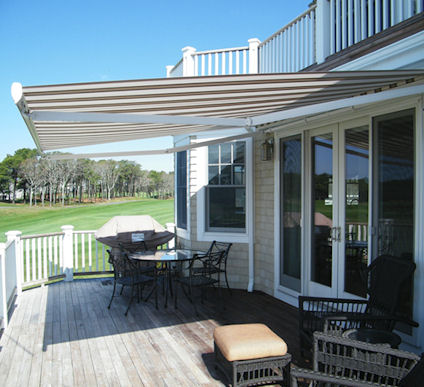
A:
[179,141,249,290]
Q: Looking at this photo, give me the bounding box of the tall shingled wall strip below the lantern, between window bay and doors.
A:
[255,139,274,295]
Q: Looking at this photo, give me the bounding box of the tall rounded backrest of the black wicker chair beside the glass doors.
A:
[367,255,415,317]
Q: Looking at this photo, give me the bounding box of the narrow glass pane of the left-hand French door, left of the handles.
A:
[311,133,333,287]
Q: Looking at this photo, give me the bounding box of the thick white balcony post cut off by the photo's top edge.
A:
[315,0,333,63]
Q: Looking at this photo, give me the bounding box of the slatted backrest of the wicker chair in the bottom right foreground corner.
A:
[313,332,422,386]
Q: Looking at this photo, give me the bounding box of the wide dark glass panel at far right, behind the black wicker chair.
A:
[373,110,415,324]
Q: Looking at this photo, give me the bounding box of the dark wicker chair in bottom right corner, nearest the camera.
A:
[291,332,424,387]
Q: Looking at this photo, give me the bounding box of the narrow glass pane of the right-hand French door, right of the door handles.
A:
[344,126,369,297]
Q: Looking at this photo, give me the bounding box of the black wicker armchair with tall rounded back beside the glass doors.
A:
[299,255,418,353]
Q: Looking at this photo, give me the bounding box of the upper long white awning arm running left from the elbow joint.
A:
[29,110,249,127]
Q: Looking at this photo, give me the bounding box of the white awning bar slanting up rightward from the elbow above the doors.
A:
[252,85,424,126]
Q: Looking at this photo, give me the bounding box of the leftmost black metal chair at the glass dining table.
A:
[107,250,153,316]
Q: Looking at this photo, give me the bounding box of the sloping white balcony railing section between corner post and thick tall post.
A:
[259,5,316,73]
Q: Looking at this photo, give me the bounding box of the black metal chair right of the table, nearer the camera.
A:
[174,251,225,315]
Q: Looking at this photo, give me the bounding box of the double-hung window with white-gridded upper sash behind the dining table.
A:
[206,141,246,232]
